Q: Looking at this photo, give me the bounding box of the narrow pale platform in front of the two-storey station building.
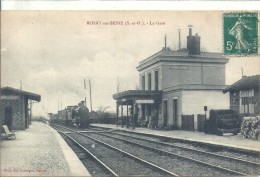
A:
[91,124,260,153]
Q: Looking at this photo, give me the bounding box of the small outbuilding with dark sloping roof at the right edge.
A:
[223,75,260,115]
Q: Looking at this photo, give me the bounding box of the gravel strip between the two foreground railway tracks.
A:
[85,133,254,176]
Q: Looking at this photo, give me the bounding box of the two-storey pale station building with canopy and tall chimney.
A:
[113,28,229,130]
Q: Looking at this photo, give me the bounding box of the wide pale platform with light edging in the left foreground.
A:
[0,122,90,177]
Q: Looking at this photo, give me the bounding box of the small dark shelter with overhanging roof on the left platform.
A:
[0,87,41,130]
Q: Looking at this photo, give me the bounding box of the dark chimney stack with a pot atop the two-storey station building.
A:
[187,25,200,55]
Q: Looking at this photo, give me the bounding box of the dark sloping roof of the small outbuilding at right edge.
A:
[223,75,260,93]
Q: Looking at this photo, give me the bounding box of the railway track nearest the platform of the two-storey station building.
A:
[94,132,260,176]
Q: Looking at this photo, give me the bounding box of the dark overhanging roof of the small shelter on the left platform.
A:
[0,87,41,102]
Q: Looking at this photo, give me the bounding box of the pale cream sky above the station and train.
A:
[1,11,260,115]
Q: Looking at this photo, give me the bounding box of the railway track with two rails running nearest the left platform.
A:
[50,125,177,176]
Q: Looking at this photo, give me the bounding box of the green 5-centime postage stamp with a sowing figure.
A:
[223,12,258,55]
